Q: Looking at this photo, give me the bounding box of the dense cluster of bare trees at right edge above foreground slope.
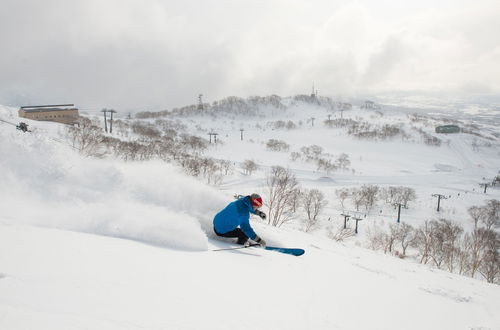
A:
[368,200,500,284]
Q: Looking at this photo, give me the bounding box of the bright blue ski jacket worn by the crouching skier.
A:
[214,196,257,239]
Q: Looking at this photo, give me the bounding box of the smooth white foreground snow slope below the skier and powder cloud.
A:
[0,224,500,330]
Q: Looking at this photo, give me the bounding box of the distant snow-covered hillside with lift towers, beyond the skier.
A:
[180,99,500,233]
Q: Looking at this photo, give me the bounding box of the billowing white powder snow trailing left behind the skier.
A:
[0,113,226,250]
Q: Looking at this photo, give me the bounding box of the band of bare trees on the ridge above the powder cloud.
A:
[65,117,234,184]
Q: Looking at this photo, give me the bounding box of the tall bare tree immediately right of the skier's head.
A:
[267,166,298,227]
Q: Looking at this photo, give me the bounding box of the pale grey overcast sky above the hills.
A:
[0,0,500,110]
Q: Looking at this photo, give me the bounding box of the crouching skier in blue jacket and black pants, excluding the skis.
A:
[214,194,266,247]
